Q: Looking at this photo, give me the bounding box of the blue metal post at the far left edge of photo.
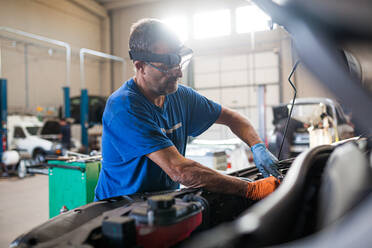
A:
[0,78,8,162]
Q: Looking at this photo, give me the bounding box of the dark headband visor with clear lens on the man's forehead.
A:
[129,46,193,69]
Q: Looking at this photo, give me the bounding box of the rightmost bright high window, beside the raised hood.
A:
[236,5,271,34]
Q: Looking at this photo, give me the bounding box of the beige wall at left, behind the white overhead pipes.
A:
[0,0,110,112]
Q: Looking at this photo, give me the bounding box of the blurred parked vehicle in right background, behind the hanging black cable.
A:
[269,98,354,155]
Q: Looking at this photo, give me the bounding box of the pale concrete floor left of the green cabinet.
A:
[0,175,49,247]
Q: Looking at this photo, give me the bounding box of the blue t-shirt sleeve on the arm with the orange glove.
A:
[104,96,173,161]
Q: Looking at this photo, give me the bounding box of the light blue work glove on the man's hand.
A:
[251,143,280,178]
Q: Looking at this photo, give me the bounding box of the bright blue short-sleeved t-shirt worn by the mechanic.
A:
[95,79,221,200]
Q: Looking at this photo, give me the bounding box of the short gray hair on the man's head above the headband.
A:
[129,18,181,52]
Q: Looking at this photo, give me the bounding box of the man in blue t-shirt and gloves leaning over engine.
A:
[96,19,278,200]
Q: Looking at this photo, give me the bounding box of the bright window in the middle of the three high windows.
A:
[194,9,231,39]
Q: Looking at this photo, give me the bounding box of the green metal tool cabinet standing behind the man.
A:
[48,160,101,218]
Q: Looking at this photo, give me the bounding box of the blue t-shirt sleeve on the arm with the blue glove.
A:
[188,88,221,137]
